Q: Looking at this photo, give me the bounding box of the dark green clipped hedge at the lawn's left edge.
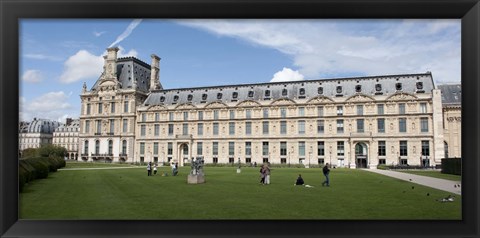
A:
[18,157,66,192]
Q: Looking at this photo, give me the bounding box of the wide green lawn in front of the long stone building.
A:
[19,167,461,220]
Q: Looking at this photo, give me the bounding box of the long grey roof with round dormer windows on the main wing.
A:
[144,72,434,106]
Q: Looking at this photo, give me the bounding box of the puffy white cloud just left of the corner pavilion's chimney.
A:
[60,50,104,83]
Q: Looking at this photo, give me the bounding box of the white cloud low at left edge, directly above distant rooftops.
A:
[19,91,78,121]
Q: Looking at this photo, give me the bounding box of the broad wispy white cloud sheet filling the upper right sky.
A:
[178,20,461,83]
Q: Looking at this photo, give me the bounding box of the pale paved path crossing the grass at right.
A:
[365,169,462,195]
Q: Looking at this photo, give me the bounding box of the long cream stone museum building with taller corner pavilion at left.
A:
[79,48,445,168]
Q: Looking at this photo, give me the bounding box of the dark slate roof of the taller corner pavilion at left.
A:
[90,57,151,92]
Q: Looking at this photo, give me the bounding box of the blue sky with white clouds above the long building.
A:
[19,19,461,122]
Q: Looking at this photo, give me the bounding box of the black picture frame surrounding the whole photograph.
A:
[0,0,480,237]
